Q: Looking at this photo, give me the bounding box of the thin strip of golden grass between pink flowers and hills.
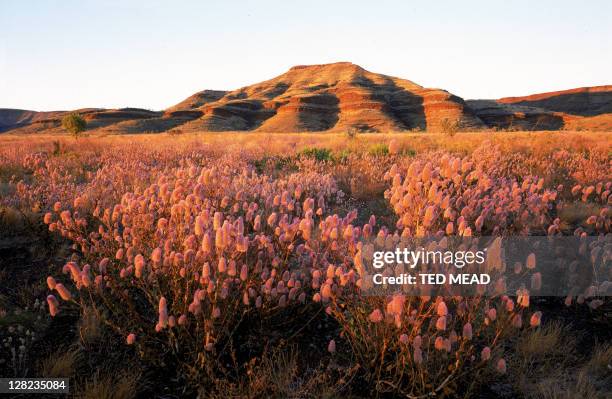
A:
[0,131,612,160]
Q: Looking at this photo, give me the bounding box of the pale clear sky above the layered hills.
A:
[0,0,612,111]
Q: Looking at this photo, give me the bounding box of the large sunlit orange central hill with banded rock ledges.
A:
[171,62,483,132]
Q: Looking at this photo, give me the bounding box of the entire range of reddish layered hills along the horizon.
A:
[0,62,612,133]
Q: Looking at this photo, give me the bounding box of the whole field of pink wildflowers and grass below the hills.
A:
[0,132,612,398]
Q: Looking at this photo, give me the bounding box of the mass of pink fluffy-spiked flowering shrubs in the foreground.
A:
[0,136,612,396]
